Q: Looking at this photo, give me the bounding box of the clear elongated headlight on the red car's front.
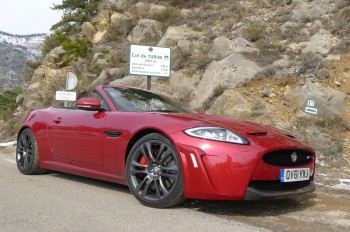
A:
[184,127,249,144]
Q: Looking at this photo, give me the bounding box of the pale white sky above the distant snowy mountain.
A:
[0,0,62,35]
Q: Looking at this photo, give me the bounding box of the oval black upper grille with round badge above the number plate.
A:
[262,150,314,167]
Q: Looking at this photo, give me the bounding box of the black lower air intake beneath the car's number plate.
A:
[249,180,310,191]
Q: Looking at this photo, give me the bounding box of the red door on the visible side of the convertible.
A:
[48,109,107,165]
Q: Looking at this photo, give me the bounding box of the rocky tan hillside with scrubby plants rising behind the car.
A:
[7,0,350,168]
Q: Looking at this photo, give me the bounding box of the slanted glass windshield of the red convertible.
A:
[105,87,192,113]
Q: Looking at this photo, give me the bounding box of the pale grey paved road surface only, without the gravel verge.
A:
[0,153,267,232]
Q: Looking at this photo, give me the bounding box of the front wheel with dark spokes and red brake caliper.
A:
[126,133,184,208]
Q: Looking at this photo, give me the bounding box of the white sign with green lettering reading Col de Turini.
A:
[129,45,171,77]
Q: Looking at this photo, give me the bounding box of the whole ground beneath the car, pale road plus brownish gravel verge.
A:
[0,150,350,232]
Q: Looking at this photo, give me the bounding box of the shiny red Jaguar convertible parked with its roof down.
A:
[16,86,316,208]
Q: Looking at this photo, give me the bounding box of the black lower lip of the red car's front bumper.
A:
[244,181,316,200]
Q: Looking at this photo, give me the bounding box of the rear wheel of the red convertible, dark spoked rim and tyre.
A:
[16,128,46,175]
